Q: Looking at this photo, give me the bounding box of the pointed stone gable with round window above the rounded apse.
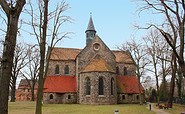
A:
[77,36,116,72]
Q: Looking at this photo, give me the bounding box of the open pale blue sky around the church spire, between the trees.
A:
[31,0,160,49]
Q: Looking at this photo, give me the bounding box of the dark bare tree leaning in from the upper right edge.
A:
[139,0,185,77]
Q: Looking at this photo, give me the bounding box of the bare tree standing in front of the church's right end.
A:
[121,39,148,105]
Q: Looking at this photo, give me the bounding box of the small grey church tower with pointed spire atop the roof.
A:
[85,15,96,45]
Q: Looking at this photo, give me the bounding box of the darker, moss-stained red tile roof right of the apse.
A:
[116,76,144,94]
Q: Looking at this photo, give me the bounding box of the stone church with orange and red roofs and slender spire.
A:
[43,16,144,104]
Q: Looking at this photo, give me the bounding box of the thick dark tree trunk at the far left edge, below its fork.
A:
[0,15,18,114]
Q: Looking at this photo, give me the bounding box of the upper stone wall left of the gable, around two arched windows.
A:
[47,60,76,76]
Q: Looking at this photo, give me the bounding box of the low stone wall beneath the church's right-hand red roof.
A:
[118,94,144,104]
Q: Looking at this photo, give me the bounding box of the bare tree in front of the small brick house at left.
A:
[21,45,40,101]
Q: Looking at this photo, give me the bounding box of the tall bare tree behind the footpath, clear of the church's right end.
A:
[143,29,170,103]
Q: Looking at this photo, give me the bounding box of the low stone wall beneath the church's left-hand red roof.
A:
[43,93,77,104]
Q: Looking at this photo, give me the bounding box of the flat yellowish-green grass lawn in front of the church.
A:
[9,102,155,114]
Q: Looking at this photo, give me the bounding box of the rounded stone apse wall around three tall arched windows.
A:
[79,72,117,104]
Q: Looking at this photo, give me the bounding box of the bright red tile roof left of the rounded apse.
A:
[43,76,76,93]
